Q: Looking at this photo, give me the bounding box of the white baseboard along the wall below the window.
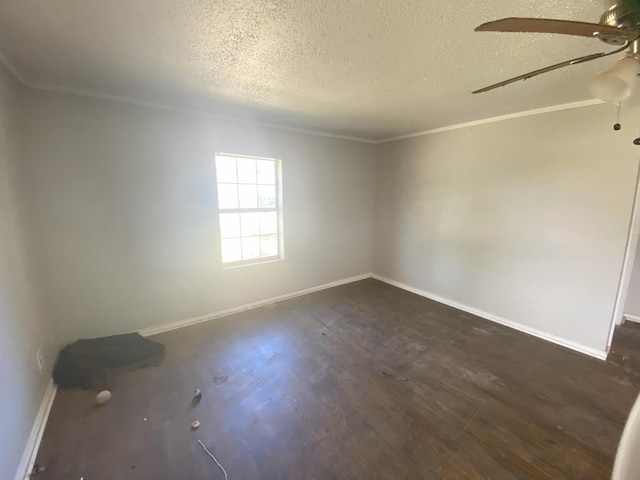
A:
[138,273,373,337]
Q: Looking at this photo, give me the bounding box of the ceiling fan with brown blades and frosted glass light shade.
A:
[473,0,640,103]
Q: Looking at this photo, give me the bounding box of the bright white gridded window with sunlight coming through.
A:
[216,153,282,266]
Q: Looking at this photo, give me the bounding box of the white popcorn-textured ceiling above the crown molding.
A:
[0,0,613,140]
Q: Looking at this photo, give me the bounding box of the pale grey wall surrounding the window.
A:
[22,91,375,342]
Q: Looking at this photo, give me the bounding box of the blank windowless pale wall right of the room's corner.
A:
[374,105,640,351]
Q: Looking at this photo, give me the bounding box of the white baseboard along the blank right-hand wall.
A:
[372,274,607,360]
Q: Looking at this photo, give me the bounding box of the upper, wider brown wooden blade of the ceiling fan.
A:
[476,17,638,41]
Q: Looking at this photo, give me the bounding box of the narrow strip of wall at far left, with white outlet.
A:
[0,65,54,479]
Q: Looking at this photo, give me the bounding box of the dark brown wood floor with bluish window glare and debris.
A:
[34,280,640,480]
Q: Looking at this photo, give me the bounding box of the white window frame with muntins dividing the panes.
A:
[214,152,284,269]
